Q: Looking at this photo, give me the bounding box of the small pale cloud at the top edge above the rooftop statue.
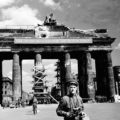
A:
[40,0,62,10]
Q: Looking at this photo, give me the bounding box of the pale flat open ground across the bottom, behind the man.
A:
[0,103,120,120]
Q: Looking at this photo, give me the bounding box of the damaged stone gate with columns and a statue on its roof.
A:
[0,16,115,103]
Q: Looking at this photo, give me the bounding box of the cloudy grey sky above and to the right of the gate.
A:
[0,0,120,92]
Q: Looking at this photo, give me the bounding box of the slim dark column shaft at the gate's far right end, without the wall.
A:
[105,51,115,99]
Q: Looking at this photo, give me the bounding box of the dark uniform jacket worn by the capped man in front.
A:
[56,94,84,120]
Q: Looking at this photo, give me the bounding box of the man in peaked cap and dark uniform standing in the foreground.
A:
[56,79,89,120]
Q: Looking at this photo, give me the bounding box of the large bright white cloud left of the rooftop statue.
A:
[0,5,42,26]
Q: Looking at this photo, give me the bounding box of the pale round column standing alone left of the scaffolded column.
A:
[13,53,21,101]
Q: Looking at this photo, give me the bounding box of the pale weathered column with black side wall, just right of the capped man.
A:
[78,52,95,99]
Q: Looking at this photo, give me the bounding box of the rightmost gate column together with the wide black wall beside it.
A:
[96,51,115,100]
